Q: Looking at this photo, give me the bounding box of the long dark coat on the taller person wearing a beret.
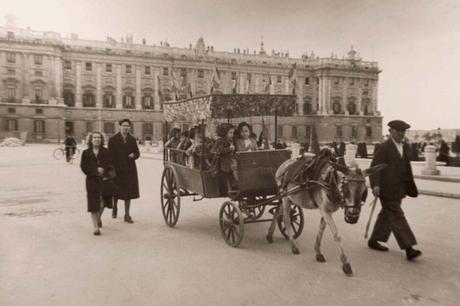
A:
[109,133,140,200]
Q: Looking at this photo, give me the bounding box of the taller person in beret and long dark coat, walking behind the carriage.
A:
[109,119,140,223]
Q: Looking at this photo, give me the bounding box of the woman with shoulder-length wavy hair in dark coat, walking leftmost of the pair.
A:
[80,132,113,236]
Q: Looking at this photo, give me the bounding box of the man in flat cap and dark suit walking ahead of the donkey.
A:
[368,120,422,260]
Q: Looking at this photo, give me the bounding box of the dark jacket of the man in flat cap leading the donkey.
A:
[370,138,418,200]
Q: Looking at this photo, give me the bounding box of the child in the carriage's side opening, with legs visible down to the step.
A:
[211,123,237,193]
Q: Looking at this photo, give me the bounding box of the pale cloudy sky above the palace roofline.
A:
[0,0,460,129]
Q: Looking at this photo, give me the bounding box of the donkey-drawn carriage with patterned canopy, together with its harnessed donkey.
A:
[161,94,384,275]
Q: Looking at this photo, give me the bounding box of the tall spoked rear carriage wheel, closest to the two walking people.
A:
[161,168,180,227]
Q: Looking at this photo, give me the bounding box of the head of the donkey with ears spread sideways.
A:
[332,164,386,224]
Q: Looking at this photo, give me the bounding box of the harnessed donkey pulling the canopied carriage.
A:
[267,157,386,276]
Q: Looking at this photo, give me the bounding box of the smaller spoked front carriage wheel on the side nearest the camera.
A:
[219,201,244,247]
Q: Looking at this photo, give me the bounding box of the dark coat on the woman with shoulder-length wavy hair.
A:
[80,147,113,212]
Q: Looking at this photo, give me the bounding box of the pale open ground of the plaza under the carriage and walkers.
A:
[0,145,460,305]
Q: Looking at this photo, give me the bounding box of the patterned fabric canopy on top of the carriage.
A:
[163,94,296,122]
